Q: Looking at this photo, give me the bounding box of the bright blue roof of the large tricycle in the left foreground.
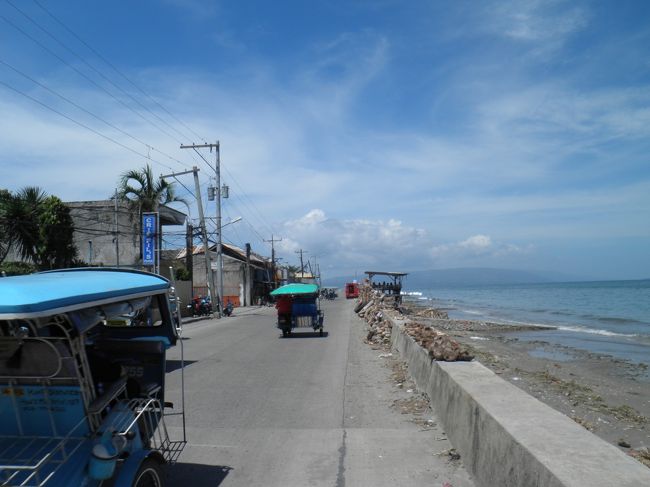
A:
[0,268,169,319]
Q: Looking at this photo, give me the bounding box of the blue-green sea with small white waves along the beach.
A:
[405,280,650,364]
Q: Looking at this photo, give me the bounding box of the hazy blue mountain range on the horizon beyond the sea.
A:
[323,267,579,289]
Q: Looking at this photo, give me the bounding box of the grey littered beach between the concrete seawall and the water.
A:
[403,300,650,467]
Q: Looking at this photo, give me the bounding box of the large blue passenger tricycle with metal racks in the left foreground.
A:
[0,268,186,487]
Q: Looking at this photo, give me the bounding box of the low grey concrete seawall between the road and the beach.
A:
[386,317,650,487]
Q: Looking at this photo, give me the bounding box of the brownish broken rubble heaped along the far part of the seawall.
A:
[355,284,473,362]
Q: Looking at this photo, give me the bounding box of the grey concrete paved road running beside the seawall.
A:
[162,298,473,487]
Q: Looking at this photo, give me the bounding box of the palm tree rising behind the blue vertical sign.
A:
[118,164,187,262]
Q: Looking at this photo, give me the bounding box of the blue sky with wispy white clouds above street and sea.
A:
[0,0,650,279]
